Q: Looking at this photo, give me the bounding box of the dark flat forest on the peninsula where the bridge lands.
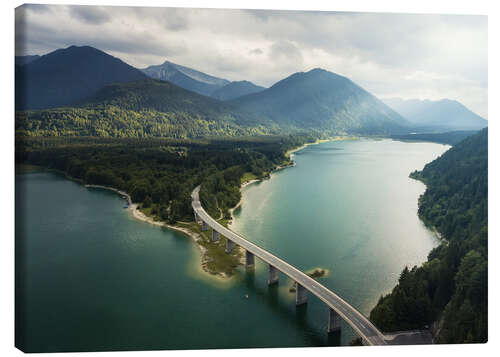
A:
[16,136,313,223]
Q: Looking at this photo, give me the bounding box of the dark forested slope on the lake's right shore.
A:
[370,129,488,343]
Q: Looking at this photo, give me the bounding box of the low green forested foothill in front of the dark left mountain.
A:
[15,79,275,138]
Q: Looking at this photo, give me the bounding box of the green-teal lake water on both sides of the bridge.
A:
[16,140,448,352]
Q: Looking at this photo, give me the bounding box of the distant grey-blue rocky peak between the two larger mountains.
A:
[142,61,230,96]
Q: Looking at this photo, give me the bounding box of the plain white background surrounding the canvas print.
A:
[0,0,500,357]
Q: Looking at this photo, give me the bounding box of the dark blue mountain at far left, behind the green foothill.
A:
[16,46,146,110]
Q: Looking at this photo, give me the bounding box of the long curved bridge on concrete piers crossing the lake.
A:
[191,186,387,345]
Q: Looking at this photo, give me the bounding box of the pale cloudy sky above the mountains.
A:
[16,5,488,118]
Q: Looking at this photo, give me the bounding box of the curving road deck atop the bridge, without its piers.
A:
[191,186,387,345]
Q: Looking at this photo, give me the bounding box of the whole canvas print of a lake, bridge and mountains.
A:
[15,2,488,352]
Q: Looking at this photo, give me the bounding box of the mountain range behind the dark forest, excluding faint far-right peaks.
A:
[16,46,420,137]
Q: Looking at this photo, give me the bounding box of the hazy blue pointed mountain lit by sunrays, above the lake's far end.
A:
[228,68,408,134]
